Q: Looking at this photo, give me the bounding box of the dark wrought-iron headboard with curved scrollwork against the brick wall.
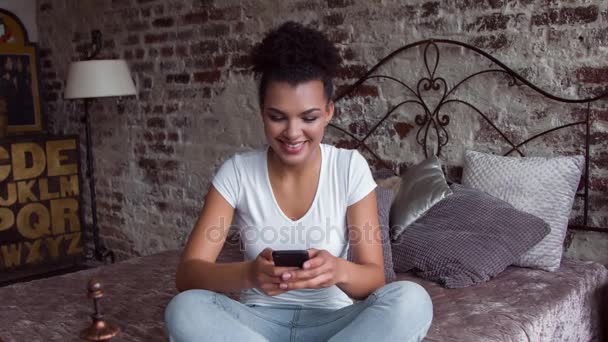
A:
[329,39,608,233]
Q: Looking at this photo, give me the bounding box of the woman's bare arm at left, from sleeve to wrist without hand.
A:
[175,185,252,292]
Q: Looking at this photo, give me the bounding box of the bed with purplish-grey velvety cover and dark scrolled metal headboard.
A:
[0,40,608,342]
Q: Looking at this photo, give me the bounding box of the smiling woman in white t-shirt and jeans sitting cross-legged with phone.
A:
[165,22,433,341]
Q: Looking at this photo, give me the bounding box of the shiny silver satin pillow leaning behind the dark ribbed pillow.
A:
[389,156,452,241]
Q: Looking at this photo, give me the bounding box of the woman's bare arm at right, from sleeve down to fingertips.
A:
[280,191,385,299]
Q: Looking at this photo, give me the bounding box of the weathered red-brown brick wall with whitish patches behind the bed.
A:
[38,0,608,263]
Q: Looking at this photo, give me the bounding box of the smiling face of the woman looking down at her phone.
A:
[262,80,334,166]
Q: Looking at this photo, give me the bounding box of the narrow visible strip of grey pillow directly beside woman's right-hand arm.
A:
[347,187,396,283]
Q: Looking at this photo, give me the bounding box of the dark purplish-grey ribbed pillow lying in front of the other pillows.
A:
[392,184,550,288]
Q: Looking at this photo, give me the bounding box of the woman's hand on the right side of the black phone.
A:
[279,248,347,290]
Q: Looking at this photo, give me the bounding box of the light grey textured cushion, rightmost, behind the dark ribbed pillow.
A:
[462,151,584,271]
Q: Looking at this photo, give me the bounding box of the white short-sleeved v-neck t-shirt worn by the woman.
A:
[213,144,376,309]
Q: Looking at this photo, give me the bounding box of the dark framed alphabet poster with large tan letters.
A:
[0,135,84,282]
